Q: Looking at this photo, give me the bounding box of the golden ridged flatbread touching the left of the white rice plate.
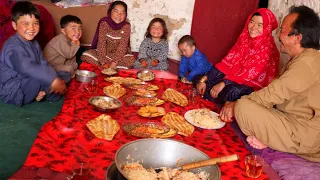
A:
[162,112,194,136]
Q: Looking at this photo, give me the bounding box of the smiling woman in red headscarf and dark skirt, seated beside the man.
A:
[197,8,280,104]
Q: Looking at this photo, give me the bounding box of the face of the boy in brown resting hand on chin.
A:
[61,22,82,41]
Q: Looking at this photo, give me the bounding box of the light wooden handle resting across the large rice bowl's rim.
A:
[176,154,239,170]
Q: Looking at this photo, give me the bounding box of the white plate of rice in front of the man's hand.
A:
[184,108,226,129]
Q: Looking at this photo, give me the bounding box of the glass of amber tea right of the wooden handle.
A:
[245,155,264,178]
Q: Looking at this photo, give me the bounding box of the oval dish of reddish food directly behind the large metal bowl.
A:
[122,122,177,138]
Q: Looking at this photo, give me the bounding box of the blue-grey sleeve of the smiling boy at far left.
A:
[5,45,57,85]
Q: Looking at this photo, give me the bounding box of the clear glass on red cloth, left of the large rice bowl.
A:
[67,163,91,180]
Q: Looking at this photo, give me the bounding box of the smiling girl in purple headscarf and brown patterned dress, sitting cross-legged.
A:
[81,1,134,68]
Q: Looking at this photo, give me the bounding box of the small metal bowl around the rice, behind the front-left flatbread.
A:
[89,96,122,111]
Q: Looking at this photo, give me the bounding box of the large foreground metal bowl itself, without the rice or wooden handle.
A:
[115,139,221,180]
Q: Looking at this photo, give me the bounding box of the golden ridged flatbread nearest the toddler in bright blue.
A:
[162,88,188,106]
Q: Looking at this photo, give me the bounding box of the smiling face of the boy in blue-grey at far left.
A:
[12,14,40,41]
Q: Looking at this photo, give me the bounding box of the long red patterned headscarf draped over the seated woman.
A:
[216,8,280,90]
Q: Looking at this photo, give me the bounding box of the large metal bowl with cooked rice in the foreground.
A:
[115,139,221,180]
